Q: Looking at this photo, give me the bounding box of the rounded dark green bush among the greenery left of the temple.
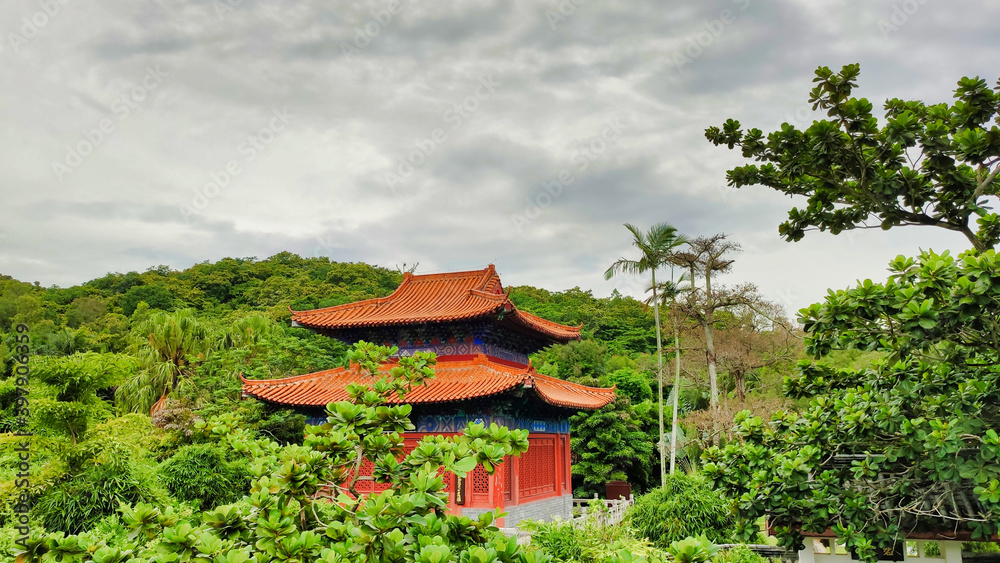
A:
[160,444,250,510]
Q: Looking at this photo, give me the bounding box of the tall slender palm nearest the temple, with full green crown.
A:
[604,223,687,487]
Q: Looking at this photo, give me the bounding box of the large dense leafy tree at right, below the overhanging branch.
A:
[704,250,1000,554]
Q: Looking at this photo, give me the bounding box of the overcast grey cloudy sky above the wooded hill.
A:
[0,0,1000,316]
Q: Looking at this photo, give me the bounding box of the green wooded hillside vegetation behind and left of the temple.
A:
[0,252,800,551]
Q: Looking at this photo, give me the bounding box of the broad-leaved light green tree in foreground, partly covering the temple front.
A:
[11,342,549,563]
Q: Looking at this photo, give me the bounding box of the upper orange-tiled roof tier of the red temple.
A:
[292,264,583,342]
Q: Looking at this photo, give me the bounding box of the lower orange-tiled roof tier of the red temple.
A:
[240,354,615,410]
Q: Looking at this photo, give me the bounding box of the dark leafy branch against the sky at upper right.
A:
[705,64,1000,250]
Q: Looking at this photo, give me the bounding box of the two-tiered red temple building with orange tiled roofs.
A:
[243,265,614,527]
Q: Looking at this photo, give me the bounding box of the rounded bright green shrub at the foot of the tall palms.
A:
[627,474,734,548]
